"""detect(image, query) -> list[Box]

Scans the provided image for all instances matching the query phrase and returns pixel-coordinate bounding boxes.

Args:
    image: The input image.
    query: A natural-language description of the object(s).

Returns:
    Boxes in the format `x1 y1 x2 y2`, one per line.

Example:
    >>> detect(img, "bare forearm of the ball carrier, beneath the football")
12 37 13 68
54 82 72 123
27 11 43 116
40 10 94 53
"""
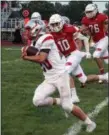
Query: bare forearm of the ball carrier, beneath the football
22 49 50 63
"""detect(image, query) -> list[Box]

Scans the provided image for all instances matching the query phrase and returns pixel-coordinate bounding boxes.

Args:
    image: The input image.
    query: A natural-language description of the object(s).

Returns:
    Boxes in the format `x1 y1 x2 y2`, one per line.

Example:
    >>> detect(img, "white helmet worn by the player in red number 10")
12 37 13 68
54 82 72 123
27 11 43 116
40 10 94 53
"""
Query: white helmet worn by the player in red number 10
49 14 64 32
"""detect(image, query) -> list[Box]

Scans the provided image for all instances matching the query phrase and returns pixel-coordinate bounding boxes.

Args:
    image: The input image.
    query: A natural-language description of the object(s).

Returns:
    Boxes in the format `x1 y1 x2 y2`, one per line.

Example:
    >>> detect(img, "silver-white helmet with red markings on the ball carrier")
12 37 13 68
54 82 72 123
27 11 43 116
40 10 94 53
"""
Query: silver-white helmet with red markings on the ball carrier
25 20 45 40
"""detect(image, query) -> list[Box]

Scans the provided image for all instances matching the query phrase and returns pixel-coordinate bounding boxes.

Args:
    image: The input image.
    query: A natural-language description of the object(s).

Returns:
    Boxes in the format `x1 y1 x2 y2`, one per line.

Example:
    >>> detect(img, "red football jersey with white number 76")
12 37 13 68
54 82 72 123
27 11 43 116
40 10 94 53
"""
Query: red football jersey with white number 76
81 13 108 43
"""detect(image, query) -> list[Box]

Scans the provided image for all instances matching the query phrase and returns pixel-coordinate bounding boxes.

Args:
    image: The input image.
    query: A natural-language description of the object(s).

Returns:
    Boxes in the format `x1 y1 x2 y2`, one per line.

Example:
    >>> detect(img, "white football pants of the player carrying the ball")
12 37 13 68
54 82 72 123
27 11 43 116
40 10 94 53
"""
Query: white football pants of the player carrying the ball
33 73 73 112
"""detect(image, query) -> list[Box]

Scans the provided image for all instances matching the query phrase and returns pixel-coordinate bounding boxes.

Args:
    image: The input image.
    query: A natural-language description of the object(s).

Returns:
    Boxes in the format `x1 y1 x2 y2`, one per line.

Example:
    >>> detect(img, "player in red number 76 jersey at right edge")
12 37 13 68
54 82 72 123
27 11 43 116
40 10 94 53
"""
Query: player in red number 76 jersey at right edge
81 4 109 82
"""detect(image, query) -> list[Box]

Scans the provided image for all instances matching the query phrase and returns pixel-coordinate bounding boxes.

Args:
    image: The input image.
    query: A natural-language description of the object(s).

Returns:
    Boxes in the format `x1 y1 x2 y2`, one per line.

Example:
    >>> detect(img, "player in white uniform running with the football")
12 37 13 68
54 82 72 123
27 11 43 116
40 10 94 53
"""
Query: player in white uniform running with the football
22 21 96 132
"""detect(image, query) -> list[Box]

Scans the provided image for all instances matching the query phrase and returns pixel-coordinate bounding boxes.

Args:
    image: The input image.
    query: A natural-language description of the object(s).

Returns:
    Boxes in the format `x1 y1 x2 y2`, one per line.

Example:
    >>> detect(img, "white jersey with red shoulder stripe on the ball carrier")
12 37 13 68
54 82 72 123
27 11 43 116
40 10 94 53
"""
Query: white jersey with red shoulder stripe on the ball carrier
31 34 66 82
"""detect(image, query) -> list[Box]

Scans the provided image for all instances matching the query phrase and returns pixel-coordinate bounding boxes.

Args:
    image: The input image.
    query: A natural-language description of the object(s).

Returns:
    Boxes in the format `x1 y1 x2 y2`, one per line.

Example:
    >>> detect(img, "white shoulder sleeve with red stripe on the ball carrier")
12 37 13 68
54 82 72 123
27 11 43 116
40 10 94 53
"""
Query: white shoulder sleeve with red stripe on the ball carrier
40 35 54 50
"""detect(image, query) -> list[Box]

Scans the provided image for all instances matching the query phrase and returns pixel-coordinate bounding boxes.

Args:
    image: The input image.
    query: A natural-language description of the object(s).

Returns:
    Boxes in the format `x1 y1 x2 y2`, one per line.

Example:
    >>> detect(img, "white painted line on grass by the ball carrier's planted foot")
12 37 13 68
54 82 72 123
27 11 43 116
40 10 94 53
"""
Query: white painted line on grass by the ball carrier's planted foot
63 97 108 135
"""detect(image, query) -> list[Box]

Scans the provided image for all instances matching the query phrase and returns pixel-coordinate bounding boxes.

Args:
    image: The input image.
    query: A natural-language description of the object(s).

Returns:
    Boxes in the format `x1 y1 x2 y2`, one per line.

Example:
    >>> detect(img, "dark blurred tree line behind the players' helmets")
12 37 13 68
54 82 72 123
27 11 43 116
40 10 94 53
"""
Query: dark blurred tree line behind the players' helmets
23 0 92 23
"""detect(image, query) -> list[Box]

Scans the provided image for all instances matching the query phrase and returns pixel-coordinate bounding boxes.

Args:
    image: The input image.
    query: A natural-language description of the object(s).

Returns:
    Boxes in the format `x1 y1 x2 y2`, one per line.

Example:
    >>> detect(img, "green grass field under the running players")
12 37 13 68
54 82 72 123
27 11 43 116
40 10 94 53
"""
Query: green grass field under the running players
1 47 108 135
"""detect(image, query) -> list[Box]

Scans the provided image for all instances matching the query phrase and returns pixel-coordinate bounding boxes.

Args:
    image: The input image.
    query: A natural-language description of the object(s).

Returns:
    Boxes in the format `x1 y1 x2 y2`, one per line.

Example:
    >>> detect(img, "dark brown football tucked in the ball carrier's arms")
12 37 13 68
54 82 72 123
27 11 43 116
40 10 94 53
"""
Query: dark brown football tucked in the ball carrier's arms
22 46 38 56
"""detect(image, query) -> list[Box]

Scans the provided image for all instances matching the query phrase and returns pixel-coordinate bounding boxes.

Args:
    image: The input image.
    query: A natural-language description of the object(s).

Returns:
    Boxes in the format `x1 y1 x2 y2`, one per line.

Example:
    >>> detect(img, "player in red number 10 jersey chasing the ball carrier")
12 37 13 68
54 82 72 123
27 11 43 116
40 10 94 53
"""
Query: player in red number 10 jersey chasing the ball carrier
49 14 108 92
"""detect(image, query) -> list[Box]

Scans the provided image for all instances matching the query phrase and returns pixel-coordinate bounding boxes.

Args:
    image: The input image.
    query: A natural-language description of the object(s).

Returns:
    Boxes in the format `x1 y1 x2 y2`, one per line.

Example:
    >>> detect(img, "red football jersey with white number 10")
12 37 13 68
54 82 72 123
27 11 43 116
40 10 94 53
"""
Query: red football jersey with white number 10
51 24 77 56
